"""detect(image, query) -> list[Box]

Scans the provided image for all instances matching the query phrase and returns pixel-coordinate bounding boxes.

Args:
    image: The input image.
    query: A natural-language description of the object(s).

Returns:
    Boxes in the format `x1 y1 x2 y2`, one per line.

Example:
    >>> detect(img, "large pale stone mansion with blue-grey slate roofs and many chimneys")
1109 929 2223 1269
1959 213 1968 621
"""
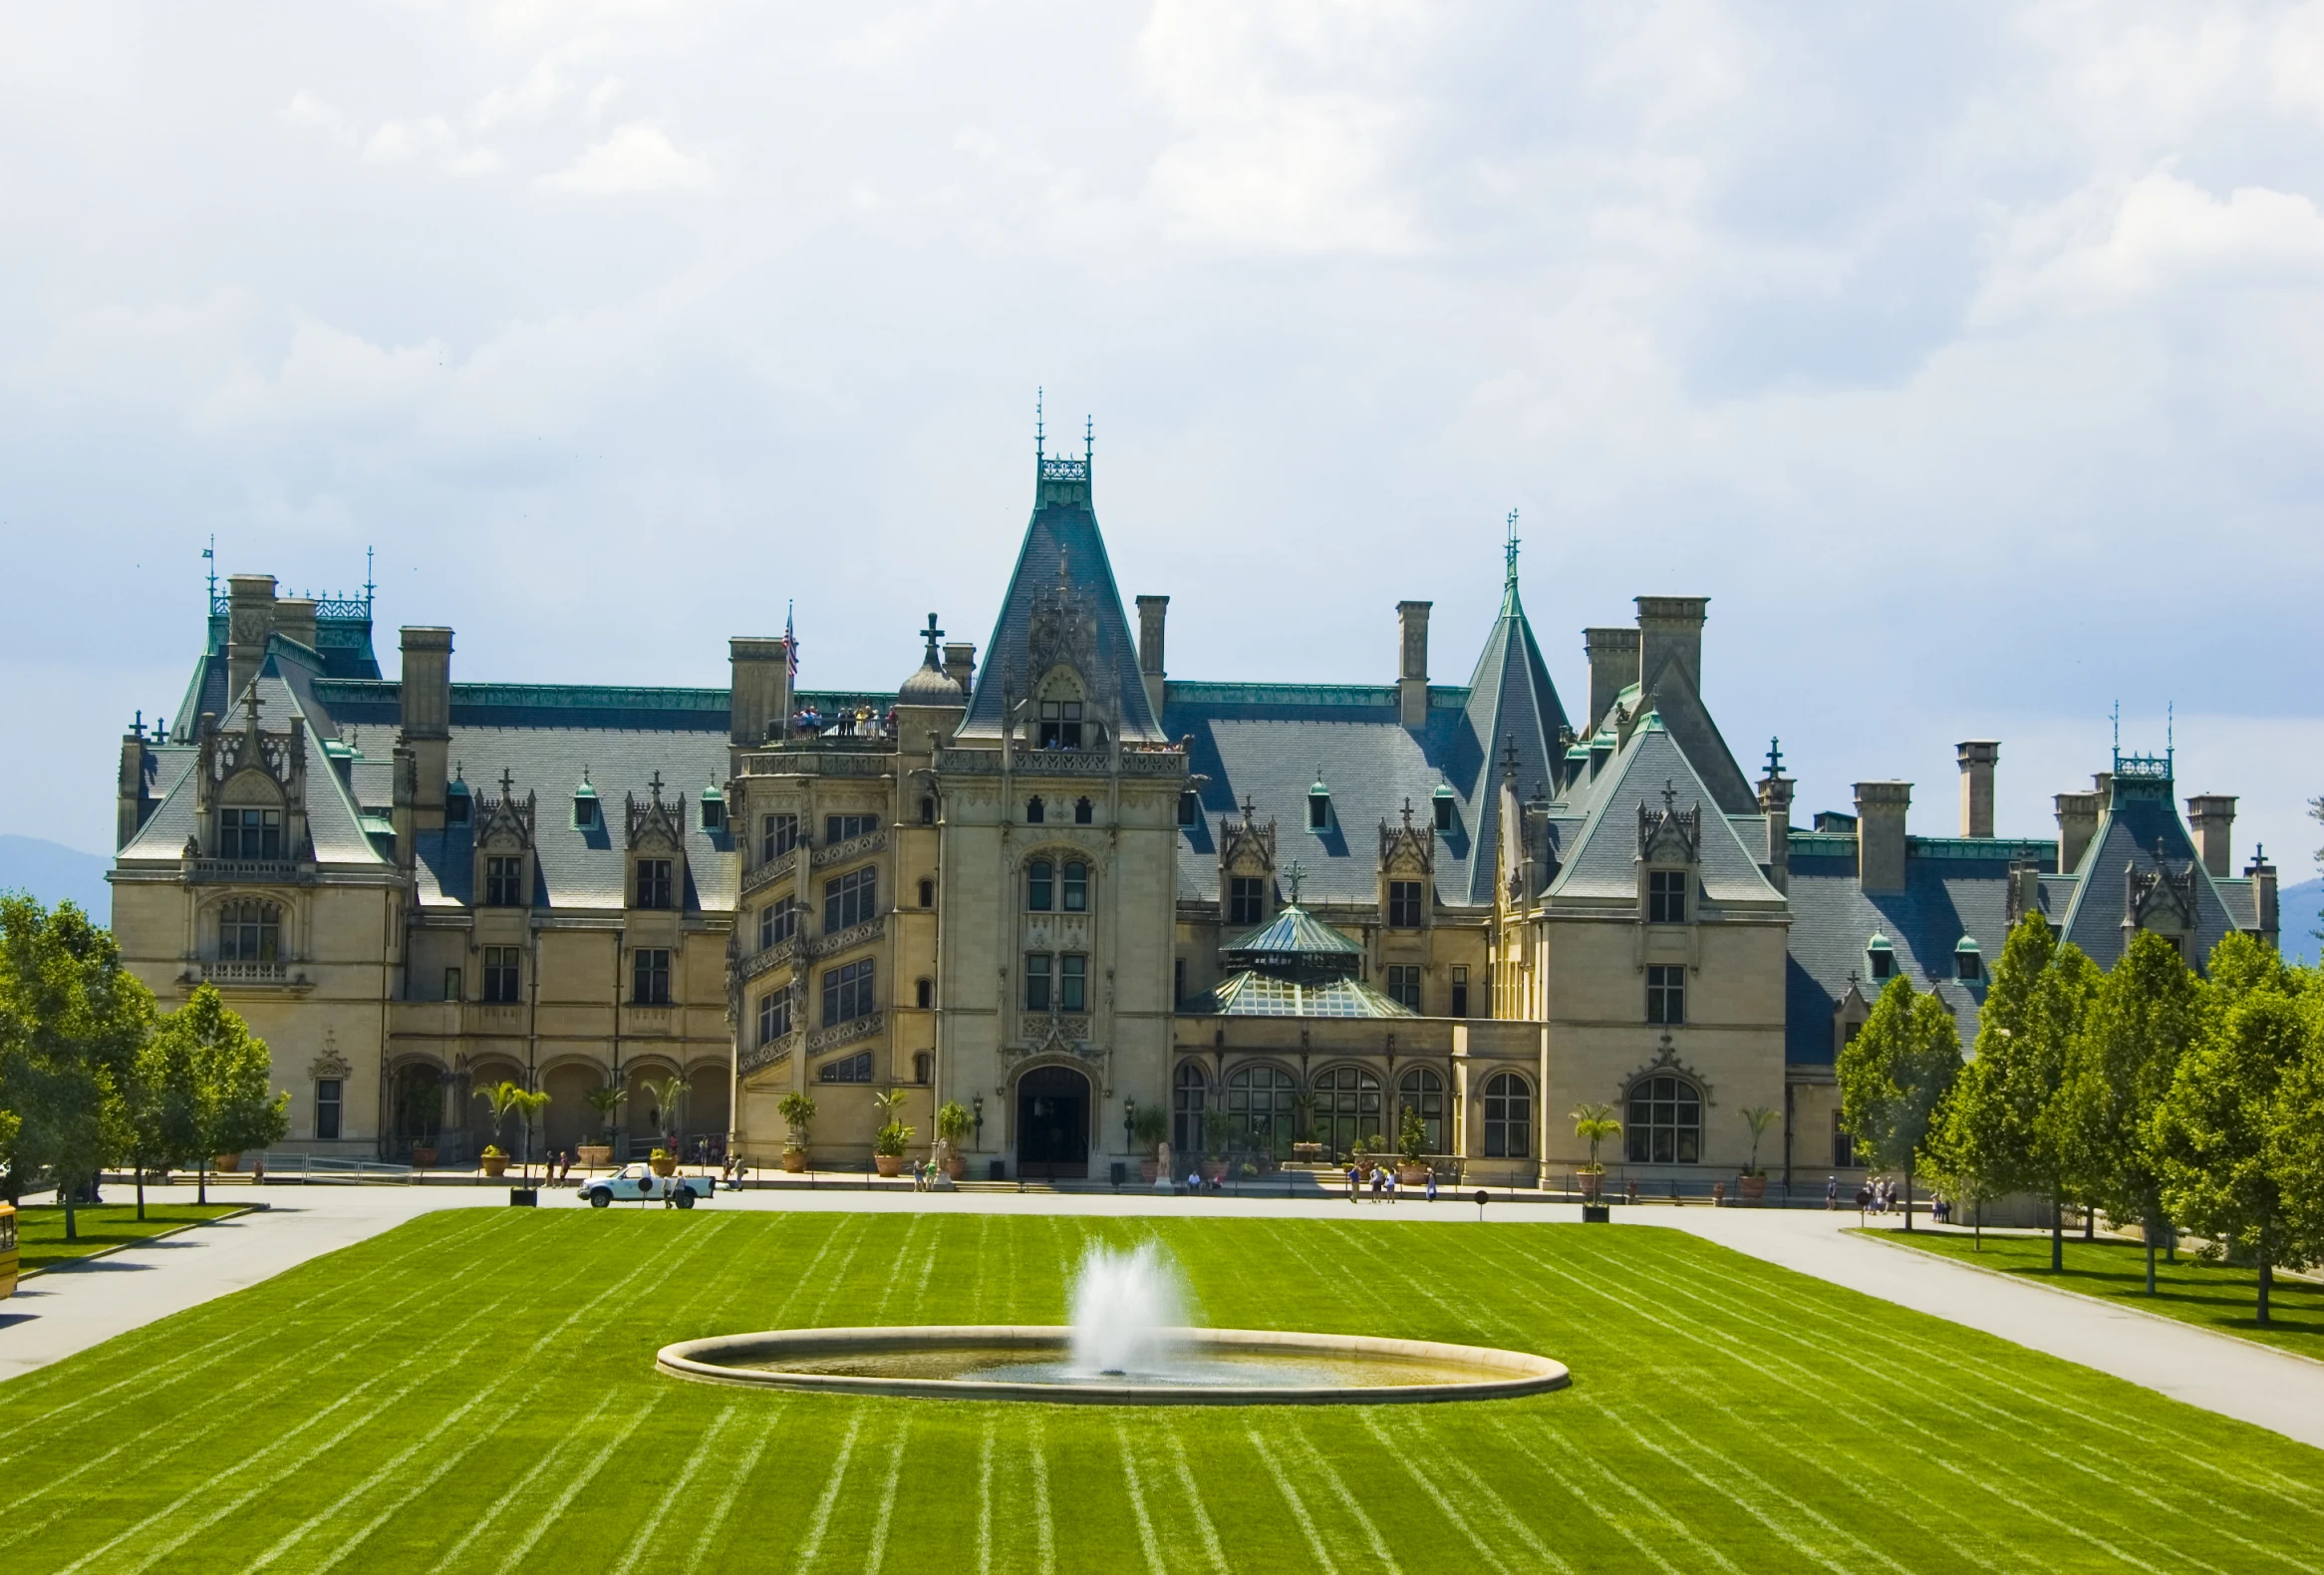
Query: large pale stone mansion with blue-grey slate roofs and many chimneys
112 432 2275 1187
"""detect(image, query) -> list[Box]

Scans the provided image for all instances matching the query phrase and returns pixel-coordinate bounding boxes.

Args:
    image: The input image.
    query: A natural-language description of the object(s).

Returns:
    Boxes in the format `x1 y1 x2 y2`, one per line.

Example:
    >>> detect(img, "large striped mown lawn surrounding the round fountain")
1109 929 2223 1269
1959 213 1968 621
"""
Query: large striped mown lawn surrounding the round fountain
0 1208 2324 1575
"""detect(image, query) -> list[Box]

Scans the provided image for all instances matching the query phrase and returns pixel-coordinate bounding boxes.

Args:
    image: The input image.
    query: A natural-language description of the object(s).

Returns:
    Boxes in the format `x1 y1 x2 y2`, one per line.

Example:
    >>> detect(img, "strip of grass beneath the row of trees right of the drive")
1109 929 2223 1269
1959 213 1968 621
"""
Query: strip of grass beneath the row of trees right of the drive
1874 1231 2324 1359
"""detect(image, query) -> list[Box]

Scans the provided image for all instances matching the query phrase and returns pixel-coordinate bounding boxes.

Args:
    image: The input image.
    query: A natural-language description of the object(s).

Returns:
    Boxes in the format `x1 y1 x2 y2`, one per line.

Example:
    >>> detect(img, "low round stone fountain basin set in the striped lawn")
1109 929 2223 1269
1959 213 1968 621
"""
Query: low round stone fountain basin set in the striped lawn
656 1324 1569 1406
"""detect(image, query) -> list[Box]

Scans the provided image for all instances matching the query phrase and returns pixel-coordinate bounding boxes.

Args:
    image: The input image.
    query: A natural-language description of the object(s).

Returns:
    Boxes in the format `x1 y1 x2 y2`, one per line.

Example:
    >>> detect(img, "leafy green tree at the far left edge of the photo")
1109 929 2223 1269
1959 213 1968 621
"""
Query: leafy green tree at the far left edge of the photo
0 894 153 1240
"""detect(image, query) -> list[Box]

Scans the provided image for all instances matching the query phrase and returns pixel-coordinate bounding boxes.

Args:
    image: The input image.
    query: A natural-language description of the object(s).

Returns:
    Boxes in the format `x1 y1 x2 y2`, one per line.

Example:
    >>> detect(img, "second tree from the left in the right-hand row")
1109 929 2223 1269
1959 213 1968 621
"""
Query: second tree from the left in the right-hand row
1933 913 2099 1273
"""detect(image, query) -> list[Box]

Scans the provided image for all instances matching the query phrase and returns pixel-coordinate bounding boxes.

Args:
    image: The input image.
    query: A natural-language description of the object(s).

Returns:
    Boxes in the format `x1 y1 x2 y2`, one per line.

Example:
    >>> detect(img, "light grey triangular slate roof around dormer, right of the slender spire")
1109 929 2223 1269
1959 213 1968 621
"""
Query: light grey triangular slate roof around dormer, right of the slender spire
1543 711 1783 911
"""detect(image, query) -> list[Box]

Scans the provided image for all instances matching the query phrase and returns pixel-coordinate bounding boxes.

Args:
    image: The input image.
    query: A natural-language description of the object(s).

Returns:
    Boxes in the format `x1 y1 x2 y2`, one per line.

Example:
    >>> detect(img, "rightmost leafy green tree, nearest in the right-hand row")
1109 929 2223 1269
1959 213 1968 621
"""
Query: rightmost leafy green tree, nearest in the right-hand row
2152 931 2319 1324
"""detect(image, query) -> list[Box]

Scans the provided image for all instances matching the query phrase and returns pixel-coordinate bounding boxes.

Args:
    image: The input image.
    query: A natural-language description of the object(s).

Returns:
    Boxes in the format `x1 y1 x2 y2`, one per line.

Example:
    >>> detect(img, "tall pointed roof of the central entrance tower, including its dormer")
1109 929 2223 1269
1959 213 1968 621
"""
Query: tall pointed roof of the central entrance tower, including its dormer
960 416 1164 748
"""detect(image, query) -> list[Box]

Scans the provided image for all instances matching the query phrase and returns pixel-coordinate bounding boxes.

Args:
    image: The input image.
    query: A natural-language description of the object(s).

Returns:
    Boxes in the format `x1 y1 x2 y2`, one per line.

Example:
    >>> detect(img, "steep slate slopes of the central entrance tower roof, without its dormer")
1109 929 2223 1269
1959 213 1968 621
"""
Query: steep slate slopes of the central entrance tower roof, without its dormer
960 456 1164 744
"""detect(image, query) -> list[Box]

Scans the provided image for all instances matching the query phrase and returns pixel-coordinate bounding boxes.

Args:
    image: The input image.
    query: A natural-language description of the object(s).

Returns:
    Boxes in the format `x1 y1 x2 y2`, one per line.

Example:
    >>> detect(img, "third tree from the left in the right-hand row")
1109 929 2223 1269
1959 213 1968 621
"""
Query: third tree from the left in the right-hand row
2059 929 2203 1296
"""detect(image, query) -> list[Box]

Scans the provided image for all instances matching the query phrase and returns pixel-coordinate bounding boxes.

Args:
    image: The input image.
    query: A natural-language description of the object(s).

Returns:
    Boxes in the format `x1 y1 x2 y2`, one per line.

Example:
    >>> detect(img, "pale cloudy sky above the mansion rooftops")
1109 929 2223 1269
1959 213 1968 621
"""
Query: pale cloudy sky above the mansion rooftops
0 0 2324 880
